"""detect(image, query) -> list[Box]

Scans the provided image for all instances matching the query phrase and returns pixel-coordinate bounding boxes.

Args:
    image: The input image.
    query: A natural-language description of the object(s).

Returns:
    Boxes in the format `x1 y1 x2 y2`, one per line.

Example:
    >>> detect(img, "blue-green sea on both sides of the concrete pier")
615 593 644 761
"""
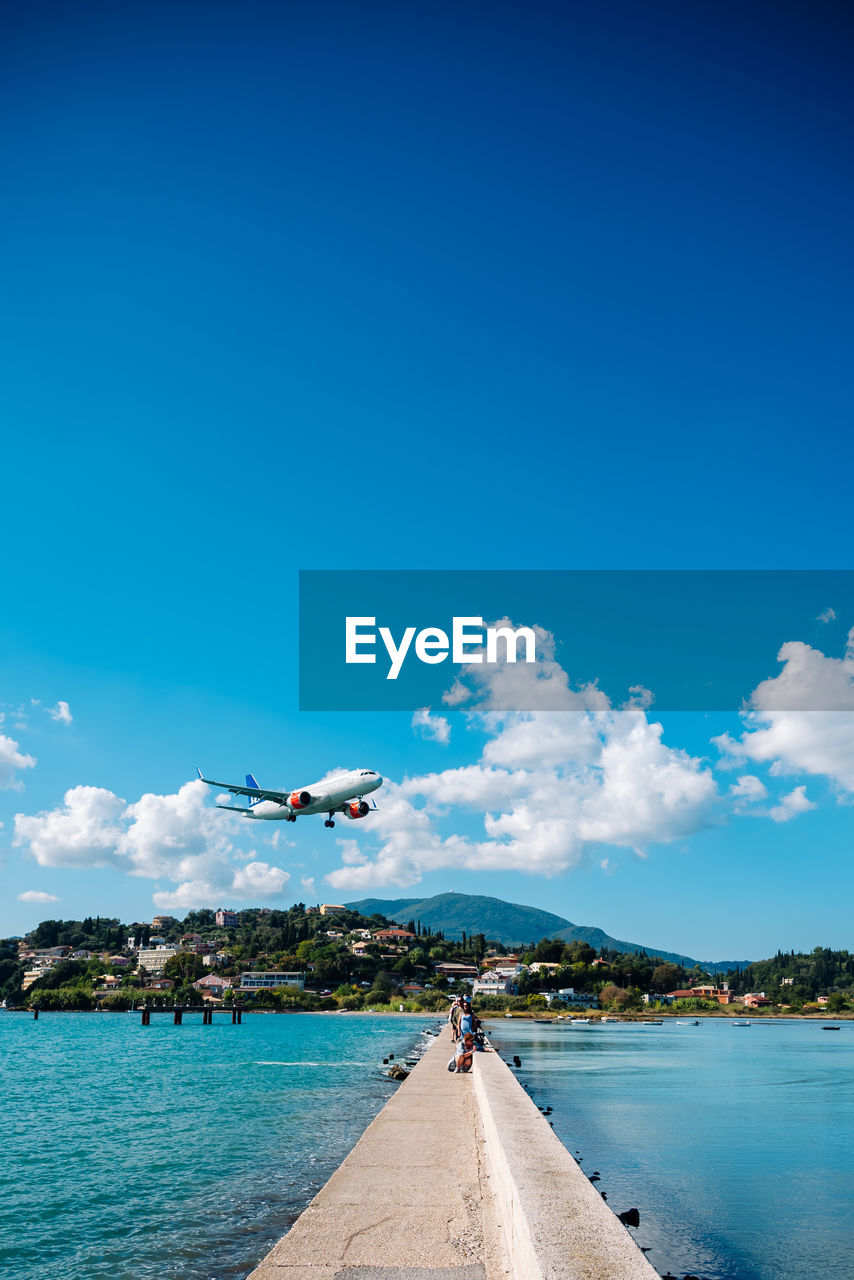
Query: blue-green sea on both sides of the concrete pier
0 1011 854 1280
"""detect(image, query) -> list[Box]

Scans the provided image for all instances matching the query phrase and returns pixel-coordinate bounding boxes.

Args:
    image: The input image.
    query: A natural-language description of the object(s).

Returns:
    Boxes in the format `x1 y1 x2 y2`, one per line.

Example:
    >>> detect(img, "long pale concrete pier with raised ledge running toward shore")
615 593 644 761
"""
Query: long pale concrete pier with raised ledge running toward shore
248 1029 658 1280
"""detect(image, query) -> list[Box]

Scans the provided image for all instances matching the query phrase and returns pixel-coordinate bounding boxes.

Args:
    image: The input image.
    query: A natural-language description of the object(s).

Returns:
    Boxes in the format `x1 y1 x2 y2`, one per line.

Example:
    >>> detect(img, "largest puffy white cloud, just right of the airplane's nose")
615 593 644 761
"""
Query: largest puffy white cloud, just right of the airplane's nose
326 620 717 890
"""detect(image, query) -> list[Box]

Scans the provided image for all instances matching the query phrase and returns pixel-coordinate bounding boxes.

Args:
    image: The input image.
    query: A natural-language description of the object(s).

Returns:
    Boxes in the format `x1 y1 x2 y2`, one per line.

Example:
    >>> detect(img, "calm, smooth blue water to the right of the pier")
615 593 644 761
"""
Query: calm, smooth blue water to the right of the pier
489 1019 854 1280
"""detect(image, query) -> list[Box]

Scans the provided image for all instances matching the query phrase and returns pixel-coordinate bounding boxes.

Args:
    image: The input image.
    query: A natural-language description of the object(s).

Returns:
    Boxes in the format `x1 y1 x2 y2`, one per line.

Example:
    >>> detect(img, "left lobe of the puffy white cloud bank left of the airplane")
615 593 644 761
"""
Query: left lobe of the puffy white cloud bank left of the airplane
13 787 125 868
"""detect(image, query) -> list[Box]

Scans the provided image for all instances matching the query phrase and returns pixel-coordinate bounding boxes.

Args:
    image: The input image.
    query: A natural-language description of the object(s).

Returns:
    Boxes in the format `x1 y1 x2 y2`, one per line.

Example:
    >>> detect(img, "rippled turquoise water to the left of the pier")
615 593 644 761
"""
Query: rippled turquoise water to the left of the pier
0 1012 437 1280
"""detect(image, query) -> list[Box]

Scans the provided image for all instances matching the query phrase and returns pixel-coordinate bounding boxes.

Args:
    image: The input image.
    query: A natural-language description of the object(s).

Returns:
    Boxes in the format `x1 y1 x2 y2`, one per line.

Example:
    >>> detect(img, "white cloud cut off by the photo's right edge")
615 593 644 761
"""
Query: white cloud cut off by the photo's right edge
713 630 854 792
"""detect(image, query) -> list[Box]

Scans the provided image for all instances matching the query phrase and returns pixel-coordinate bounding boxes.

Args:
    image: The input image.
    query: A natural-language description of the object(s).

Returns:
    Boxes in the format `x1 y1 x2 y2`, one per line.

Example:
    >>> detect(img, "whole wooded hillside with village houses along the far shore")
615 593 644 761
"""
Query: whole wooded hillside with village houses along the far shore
0 902 854 1014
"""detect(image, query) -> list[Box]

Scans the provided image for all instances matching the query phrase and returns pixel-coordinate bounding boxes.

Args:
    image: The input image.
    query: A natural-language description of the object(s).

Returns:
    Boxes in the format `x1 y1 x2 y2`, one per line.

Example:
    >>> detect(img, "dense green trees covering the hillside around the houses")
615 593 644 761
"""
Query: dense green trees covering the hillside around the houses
0 902 854 1012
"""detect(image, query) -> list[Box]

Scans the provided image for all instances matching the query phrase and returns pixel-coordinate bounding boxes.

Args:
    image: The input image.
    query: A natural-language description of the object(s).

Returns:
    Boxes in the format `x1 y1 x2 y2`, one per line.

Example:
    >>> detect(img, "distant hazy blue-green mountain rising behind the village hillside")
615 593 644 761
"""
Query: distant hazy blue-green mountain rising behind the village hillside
347 893 749 973
